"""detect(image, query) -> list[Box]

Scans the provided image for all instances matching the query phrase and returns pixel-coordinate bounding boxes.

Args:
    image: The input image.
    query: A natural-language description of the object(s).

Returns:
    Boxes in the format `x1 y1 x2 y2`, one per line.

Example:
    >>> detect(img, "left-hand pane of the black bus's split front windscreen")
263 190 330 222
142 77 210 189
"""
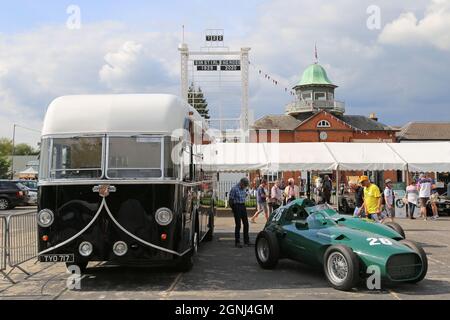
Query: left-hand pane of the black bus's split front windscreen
48 137 103 179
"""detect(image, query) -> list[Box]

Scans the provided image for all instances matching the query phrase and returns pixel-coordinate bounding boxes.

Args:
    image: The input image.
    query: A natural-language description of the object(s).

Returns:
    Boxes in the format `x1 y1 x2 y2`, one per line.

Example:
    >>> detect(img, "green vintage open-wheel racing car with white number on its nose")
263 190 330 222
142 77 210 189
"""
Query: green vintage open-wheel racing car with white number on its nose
255 199 428 290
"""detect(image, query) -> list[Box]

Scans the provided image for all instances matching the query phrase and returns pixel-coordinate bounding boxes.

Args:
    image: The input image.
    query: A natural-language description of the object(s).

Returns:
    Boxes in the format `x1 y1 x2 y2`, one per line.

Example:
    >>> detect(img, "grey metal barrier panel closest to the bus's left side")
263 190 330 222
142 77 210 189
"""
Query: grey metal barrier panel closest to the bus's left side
8 212 38 271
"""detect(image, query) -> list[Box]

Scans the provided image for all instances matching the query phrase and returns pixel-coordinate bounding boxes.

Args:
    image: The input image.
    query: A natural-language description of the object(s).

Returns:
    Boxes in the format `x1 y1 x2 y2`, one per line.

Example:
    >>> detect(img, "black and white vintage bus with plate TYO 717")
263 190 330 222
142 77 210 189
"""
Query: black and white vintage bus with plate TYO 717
37 94 216 271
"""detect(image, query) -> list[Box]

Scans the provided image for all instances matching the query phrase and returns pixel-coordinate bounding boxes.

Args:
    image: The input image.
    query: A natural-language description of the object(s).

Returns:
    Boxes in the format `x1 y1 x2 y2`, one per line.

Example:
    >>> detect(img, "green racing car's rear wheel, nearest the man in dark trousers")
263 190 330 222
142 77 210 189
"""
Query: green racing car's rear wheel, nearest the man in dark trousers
255 231 280 269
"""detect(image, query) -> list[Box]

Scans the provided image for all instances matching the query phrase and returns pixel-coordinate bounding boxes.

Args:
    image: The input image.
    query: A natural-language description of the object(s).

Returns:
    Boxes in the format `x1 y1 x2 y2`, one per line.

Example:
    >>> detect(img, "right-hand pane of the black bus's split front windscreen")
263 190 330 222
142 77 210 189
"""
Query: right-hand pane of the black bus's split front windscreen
107 136 162 179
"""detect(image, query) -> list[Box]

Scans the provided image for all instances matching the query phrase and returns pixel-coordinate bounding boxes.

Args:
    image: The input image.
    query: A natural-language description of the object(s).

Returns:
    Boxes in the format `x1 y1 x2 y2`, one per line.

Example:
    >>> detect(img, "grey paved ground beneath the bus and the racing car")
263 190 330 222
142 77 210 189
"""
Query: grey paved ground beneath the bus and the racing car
0 217 450 300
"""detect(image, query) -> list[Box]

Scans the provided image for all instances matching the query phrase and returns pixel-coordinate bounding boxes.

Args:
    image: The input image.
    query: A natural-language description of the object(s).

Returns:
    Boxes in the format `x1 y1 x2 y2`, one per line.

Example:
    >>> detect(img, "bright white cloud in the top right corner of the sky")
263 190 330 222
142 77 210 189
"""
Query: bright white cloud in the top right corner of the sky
379 0 450 51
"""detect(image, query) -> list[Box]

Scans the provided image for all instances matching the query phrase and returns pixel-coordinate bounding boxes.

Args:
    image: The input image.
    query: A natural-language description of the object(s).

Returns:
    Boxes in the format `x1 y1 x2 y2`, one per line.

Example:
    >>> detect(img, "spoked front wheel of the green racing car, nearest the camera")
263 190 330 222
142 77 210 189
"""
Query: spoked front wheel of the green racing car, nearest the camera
324 245 360 291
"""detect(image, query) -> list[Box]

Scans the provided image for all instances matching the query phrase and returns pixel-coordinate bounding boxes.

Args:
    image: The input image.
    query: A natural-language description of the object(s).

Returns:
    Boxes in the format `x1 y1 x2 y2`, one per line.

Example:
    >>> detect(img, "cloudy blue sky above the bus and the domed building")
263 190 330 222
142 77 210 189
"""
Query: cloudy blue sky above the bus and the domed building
0 0 450 145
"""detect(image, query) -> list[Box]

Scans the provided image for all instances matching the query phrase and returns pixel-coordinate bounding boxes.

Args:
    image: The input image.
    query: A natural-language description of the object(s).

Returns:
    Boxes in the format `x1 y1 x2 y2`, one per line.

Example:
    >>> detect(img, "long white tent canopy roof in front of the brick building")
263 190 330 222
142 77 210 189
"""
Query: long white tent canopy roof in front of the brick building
203 142 450 172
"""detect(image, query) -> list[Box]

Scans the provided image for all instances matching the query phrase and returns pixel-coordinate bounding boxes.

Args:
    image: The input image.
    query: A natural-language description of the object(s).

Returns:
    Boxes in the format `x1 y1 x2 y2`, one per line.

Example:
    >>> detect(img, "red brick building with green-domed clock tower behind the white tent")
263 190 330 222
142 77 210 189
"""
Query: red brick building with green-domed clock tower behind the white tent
250 63 401 188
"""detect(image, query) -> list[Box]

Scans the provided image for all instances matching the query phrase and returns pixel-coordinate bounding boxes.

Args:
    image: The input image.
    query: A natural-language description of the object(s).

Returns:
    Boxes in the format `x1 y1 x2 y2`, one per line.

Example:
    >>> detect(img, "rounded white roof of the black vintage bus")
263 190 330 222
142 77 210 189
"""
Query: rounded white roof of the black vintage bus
42 94 207 136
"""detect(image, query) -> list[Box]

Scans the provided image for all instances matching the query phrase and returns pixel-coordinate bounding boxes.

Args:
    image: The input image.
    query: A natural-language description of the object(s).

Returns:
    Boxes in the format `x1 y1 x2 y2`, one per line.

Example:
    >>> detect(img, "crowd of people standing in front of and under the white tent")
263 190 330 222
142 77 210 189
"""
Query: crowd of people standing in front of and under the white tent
229 173 439 248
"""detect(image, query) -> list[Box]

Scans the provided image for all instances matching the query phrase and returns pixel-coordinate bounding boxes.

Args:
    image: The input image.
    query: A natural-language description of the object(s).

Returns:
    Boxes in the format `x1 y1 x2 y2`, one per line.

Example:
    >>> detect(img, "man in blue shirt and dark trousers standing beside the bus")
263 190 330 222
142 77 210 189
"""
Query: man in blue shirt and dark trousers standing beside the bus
229 178 250 248
